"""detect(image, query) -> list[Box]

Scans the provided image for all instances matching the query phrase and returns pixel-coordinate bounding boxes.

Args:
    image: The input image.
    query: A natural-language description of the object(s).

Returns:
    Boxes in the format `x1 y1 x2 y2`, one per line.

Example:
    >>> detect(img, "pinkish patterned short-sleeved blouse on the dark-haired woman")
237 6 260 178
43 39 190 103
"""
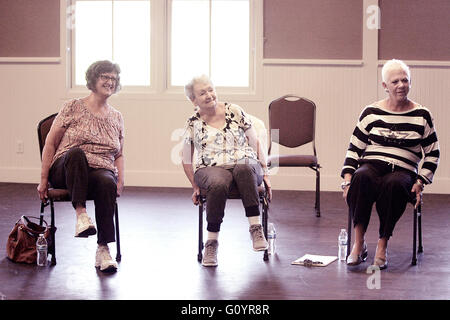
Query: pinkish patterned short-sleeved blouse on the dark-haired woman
52 99 124 174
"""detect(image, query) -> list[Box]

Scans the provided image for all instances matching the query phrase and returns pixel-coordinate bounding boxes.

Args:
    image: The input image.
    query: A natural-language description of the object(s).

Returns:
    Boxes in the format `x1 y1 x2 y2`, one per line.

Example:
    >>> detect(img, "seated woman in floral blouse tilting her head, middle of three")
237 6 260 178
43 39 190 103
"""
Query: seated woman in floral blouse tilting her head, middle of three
183 76 271 266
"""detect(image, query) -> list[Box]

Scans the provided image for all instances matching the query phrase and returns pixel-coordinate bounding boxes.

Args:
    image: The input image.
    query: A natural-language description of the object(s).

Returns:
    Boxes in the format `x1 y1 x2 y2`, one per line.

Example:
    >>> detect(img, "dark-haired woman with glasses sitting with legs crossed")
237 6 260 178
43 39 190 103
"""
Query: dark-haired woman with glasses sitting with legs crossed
37 61 124 271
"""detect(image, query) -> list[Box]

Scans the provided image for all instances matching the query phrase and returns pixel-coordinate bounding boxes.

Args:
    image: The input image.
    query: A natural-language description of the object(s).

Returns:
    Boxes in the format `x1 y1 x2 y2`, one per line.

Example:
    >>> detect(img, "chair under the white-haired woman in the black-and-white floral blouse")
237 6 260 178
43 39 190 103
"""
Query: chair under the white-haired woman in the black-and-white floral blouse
197 115 269 262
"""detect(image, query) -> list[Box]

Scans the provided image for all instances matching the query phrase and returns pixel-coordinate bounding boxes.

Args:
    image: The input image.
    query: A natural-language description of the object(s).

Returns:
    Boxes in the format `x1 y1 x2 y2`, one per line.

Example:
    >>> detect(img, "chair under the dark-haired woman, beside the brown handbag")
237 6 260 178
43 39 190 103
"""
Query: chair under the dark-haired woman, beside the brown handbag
37 113 122 266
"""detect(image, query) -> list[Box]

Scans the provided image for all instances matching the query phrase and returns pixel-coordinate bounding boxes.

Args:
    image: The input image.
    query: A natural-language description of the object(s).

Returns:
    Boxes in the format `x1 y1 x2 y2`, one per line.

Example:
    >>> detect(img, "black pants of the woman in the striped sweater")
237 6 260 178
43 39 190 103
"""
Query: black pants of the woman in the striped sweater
347 161 416 239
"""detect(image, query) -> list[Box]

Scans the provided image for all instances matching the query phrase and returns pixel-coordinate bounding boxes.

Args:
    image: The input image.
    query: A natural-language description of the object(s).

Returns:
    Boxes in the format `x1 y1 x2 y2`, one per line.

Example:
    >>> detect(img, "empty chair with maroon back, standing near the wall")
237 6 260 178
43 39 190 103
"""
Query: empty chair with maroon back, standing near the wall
268 95 321 217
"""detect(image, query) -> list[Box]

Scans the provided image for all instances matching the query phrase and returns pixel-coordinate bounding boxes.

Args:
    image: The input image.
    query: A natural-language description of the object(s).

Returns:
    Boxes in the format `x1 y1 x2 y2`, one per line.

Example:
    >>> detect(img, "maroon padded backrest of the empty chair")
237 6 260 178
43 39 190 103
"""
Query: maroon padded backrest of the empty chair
269 95 316 154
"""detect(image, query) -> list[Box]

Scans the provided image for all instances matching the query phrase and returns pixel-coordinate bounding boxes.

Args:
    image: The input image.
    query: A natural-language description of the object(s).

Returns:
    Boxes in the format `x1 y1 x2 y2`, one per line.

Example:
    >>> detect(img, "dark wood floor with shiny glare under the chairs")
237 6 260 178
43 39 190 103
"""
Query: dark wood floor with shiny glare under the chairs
0 183 450 300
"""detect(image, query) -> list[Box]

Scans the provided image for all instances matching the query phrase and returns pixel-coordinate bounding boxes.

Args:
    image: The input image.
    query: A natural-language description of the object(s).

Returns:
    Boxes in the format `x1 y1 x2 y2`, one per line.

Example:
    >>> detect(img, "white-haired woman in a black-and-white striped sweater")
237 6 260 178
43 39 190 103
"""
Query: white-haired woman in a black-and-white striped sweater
341 59 439 269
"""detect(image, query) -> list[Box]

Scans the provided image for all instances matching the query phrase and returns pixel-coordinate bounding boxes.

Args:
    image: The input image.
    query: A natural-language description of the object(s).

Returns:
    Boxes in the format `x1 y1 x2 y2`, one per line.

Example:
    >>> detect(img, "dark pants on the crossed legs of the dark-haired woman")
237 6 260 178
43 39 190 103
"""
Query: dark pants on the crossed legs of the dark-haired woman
49 148 117 244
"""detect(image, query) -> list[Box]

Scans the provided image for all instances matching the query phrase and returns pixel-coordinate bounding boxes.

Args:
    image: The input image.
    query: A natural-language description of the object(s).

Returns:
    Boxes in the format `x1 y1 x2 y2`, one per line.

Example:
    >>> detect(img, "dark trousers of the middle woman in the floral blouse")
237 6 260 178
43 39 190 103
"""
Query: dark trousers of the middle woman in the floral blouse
194 162 263 232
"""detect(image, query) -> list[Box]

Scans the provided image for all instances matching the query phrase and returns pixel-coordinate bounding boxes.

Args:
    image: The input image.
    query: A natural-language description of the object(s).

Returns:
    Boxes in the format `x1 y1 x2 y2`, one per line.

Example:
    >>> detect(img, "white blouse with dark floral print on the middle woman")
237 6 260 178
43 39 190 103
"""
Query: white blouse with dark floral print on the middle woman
184 103 257 171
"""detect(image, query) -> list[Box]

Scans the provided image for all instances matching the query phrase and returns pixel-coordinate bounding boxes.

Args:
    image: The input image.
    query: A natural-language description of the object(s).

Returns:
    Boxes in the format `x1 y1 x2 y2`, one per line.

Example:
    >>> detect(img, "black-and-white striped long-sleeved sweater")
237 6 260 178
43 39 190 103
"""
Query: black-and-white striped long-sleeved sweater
341 105 439 184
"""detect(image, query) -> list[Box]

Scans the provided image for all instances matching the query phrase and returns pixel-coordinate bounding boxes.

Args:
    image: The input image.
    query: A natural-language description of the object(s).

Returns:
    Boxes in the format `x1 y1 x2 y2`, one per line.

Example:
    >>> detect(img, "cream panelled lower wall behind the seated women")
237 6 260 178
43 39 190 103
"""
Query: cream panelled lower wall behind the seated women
0 0 450 193
